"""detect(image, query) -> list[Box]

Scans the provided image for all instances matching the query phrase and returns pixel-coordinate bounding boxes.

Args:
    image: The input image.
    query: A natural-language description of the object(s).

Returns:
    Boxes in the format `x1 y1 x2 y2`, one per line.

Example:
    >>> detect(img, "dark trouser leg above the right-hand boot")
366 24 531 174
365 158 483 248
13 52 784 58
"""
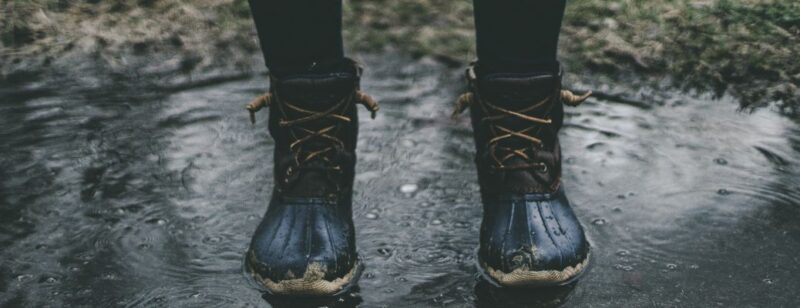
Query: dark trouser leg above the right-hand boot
473 0 566 74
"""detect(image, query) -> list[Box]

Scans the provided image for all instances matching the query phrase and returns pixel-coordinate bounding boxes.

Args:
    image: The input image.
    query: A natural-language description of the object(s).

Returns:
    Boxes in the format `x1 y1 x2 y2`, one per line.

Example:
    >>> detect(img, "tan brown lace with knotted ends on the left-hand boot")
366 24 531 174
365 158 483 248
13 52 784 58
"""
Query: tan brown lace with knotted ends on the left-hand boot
245 91 379 183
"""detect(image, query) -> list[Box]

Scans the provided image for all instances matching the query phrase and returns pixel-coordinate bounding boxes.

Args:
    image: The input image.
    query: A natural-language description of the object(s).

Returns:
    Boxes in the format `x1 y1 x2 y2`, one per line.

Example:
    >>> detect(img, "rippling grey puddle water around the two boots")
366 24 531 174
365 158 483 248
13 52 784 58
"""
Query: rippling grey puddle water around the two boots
0 57 800 307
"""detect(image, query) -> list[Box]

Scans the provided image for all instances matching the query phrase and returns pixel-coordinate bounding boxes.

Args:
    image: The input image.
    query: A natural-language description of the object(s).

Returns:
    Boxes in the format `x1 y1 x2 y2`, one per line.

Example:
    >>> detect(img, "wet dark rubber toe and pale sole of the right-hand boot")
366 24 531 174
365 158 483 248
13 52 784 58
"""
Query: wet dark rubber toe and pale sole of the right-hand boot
478 189 589 286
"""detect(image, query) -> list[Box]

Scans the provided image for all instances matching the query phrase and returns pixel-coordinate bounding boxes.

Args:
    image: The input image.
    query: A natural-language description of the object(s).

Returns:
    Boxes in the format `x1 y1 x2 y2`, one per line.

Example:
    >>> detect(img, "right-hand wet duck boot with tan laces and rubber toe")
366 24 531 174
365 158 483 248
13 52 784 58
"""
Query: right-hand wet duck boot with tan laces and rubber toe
454 65 589 287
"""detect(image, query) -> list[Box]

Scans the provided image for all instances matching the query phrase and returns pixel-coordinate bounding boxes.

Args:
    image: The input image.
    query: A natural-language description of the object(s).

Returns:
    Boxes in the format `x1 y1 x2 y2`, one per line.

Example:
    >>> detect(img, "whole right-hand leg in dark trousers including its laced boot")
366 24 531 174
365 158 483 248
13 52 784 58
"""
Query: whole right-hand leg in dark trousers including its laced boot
459 0 589 286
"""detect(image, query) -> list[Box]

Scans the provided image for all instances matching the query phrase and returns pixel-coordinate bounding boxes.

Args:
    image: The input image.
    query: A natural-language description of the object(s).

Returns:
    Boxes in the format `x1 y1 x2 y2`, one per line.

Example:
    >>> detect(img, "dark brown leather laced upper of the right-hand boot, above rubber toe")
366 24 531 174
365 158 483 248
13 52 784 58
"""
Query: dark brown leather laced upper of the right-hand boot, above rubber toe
462 65 564 194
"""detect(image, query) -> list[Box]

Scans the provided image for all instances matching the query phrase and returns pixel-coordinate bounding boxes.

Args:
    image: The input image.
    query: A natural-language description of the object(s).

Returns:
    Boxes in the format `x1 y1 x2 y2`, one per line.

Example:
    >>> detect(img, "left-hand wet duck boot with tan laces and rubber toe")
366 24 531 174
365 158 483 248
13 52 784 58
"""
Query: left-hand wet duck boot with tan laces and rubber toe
246 59 378 296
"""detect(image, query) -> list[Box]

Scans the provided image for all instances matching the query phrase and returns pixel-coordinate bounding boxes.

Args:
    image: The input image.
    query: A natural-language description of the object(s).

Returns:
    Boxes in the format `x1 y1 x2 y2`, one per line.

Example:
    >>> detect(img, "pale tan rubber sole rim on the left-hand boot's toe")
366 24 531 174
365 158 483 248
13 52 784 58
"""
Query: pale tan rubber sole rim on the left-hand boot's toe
244 253 364 299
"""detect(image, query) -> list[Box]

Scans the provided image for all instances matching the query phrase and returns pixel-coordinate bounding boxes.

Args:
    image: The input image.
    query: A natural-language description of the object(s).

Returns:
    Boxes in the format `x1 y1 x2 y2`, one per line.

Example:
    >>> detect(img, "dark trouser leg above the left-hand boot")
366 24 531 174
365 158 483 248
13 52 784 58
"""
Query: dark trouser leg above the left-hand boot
249 0 344 76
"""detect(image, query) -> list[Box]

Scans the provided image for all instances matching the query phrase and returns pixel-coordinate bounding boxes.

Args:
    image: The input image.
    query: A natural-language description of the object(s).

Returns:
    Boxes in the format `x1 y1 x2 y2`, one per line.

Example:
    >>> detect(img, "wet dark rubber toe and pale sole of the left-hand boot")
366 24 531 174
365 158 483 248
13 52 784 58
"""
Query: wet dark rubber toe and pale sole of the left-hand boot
247 199 360 296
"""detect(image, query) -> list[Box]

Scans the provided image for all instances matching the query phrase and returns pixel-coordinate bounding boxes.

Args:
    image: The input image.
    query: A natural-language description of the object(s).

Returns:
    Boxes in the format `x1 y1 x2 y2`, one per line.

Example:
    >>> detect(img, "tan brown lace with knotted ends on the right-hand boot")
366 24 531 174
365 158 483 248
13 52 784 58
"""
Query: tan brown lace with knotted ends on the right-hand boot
452 90 592 172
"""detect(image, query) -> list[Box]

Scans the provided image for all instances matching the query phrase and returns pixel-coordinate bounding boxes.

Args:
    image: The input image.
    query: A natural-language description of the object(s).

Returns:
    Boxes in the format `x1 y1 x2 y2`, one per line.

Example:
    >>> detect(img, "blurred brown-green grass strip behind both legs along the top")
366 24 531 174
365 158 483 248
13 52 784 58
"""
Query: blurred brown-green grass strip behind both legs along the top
0 0 800 115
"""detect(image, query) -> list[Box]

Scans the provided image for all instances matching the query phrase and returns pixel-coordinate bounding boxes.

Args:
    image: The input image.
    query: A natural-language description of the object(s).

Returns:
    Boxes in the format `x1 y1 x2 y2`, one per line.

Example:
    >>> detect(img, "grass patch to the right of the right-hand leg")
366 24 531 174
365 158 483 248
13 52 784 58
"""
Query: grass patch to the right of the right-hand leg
564 0 800 115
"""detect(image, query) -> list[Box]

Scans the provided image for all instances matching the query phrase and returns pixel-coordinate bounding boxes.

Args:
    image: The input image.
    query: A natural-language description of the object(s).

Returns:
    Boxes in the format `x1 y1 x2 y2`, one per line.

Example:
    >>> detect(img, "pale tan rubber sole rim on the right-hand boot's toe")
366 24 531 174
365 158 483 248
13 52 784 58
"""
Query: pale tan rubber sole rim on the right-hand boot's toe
475 251 592 288
